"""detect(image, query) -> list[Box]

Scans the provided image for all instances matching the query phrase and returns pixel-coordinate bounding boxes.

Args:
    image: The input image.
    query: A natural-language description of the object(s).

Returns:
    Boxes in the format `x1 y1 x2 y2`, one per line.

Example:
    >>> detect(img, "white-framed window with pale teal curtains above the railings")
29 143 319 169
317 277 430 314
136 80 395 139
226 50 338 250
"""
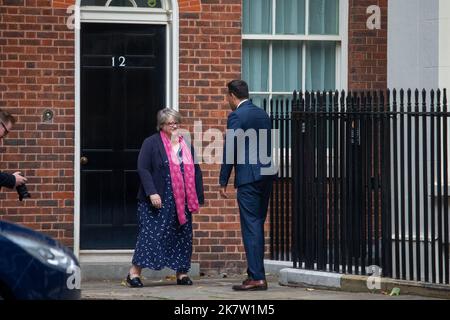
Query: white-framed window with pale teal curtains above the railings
242 0 345 105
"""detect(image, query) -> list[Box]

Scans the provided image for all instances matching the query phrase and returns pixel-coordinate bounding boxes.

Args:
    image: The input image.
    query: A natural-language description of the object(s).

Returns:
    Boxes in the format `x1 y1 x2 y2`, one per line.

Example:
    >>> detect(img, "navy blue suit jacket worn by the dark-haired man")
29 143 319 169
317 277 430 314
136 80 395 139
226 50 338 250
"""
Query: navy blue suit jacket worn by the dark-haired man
219 101 274 187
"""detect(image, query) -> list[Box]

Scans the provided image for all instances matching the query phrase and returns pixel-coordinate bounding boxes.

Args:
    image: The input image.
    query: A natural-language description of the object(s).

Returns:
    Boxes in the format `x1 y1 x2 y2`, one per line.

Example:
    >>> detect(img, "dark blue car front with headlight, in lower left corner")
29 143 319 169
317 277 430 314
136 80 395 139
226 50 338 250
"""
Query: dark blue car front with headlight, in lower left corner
0 221 81 300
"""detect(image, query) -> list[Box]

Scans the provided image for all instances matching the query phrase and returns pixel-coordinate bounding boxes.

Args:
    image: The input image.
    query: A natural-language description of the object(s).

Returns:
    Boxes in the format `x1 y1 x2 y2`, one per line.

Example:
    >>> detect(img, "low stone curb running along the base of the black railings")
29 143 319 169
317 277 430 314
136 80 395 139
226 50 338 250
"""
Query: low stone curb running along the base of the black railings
279 268 450 299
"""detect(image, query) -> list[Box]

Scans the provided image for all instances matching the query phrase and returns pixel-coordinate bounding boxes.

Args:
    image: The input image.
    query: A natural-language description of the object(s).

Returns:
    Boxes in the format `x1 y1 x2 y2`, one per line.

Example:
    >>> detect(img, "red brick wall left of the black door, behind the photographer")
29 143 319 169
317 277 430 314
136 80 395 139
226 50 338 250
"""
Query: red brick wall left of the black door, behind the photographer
0 0 75 246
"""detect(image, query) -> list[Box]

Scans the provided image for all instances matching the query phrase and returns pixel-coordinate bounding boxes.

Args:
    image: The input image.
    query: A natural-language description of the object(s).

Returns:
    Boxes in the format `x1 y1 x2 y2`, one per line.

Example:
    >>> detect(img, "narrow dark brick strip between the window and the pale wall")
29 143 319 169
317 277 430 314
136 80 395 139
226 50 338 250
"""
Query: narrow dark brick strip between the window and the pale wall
348 0 388 90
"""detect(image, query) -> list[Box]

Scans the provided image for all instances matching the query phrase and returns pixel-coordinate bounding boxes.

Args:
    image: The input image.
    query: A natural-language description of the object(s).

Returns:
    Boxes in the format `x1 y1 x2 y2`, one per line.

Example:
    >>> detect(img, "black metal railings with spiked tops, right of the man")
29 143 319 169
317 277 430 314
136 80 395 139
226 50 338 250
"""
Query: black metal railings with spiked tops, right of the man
264 90 450 284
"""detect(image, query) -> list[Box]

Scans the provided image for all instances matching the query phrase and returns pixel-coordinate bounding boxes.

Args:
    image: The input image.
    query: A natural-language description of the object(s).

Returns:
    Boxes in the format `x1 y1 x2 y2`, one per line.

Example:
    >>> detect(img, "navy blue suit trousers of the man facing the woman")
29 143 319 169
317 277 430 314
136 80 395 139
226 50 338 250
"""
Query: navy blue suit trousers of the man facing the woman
237 179 273 280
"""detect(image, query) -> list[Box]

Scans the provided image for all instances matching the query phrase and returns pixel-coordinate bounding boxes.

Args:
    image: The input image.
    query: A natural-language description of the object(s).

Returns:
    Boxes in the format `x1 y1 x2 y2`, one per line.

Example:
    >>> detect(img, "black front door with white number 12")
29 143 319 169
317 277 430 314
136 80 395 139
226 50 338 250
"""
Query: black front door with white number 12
80 23 166 250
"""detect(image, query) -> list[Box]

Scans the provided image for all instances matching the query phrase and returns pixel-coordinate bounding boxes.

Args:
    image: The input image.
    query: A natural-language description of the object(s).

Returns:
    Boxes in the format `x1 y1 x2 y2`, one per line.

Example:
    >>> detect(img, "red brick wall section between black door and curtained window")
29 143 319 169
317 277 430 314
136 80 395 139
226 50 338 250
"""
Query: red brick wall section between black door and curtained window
180 0 250 273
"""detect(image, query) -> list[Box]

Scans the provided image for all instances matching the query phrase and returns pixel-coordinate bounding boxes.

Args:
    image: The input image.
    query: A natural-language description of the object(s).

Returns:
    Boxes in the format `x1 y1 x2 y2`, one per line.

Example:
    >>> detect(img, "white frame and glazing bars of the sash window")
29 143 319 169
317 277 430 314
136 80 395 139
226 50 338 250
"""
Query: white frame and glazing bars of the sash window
242 0 349 101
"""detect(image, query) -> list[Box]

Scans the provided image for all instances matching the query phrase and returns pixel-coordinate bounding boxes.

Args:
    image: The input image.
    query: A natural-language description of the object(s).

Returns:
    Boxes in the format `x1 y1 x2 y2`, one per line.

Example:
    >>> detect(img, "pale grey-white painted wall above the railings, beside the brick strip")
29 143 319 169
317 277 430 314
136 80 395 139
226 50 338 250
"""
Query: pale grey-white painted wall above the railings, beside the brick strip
388 0 440 90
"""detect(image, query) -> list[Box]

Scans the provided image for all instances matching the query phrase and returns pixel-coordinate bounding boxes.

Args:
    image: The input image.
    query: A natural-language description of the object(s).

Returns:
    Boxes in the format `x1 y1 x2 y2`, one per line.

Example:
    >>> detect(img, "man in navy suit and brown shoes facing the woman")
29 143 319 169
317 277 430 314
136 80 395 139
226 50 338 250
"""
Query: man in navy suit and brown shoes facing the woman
219 80 274 291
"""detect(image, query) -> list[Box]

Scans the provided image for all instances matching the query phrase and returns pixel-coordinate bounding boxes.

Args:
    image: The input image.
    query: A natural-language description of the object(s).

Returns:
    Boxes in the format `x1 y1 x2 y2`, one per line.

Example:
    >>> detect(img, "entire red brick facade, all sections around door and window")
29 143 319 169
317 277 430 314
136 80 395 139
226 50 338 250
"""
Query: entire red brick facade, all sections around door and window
0 0 387 273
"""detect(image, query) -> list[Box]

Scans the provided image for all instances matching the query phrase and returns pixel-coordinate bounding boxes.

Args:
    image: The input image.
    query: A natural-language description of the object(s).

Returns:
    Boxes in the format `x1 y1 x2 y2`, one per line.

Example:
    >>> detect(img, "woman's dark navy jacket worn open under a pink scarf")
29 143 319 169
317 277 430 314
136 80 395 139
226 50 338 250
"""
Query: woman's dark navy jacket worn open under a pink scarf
137 132 205 204
